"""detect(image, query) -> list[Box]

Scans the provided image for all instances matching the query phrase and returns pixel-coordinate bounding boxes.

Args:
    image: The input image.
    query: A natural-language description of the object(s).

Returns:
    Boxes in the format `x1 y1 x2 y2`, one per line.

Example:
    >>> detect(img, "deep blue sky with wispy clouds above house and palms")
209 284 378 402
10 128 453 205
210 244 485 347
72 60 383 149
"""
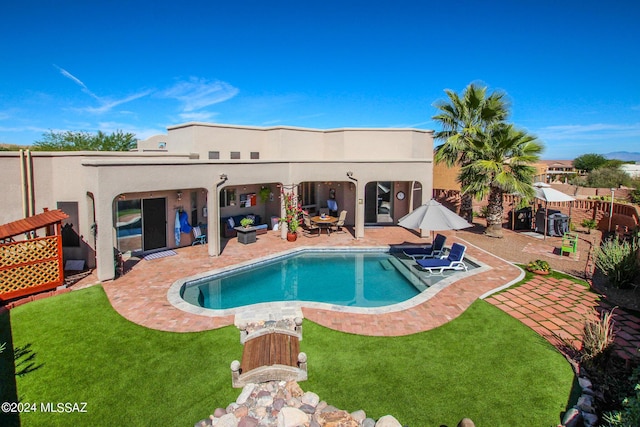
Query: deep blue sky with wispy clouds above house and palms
0 0 640 159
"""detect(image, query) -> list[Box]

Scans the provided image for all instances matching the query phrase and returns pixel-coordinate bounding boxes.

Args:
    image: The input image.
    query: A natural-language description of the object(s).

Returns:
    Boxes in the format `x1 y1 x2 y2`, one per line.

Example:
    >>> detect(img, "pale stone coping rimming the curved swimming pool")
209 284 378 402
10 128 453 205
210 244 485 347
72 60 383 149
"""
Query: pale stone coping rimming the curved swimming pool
167 245 492 324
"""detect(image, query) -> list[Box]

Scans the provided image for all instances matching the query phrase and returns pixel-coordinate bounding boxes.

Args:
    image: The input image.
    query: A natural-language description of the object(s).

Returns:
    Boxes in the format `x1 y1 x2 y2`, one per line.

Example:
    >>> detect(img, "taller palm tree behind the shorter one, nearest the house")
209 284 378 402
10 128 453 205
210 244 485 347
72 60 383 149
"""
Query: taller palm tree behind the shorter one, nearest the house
432 83 509 222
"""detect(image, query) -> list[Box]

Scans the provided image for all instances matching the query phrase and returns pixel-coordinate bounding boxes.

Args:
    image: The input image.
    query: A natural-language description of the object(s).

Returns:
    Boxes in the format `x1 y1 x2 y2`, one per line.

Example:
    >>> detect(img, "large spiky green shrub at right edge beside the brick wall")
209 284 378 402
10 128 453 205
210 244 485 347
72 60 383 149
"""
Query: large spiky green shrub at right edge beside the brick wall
595 236 640 289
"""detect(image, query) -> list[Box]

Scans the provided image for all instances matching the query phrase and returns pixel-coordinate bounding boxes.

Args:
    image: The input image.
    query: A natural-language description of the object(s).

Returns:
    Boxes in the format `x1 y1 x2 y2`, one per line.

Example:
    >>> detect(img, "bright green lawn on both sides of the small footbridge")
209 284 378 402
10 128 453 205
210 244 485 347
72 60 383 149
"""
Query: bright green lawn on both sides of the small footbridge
0 286 573 427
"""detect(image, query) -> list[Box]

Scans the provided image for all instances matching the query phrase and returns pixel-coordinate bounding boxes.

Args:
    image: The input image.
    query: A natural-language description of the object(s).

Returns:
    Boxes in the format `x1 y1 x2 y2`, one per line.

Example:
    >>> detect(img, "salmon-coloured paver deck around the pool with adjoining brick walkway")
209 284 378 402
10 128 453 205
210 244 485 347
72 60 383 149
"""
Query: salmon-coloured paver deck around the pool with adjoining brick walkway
63 227 640 358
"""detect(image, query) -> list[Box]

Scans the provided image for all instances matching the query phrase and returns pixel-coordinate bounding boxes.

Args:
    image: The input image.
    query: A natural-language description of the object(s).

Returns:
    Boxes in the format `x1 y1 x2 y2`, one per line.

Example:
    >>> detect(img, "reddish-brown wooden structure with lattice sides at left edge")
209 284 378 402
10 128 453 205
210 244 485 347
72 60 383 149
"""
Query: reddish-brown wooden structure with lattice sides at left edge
0 209 69 301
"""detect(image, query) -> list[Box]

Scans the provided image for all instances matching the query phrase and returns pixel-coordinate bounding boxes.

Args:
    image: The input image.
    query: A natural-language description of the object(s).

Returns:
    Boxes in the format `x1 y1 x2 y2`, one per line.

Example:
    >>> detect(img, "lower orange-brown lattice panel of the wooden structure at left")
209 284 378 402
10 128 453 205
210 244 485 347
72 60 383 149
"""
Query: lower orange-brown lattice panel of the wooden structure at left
0 260 62 294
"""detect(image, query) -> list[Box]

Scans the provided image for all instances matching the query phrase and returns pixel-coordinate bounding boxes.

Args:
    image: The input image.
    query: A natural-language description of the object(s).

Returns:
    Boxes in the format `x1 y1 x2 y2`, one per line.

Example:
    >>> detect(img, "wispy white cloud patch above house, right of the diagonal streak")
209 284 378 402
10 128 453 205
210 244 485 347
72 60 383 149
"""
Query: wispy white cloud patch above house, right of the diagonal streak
161 77 238 112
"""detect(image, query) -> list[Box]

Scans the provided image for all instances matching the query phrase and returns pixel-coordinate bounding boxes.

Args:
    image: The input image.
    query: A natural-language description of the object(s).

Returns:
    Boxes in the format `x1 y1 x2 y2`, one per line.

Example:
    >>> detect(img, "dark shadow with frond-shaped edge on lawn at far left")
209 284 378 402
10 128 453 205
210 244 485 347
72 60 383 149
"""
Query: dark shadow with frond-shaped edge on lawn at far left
0 307 43 427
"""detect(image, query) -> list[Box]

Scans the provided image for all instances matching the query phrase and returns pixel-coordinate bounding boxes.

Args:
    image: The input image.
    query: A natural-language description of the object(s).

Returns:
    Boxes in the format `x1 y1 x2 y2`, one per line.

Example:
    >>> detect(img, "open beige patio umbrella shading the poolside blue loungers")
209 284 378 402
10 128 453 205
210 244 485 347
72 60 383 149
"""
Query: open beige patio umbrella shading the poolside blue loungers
398 199 473 231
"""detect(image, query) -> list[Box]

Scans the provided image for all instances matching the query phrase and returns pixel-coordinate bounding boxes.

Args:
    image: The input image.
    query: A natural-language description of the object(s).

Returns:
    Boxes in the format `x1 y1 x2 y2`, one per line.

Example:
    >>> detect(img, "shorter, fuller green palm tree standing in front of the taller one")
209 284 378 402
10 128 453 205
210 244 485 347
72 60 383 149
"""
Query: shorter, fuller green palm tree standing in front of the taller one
460 123 543 237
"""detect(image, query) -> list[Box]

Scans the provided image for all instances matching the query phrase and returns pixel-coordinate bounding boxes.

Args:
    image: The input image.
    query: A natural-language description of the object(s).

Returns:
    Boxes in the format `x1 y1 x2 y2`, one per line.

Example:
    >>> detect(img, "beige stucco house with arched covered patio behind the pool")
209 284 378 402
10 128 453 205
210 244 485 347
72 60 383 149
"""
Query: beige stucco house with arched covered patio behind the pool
0 123 433 280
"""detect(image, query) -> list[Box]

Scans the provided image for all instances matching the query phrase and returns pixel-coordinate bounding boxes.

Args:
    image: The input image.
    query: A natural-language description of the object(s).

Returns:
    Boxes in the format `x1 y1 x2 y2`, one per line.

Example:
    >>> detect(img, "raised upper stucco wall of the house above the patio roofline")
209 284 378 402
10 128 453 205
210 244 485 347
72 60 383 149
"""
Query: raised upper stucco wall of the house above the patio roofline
138 123 433 164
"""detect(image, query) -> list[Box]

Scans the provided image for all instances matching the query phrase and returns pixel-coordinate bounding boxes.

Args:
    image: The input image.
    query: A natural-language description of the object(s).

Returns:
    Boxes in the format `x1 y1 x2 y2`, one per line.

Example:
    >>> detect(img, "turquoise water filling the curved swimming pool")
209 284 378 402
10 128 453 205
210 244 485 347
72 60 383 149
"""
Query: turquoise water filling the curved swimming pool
181 252 419 309
